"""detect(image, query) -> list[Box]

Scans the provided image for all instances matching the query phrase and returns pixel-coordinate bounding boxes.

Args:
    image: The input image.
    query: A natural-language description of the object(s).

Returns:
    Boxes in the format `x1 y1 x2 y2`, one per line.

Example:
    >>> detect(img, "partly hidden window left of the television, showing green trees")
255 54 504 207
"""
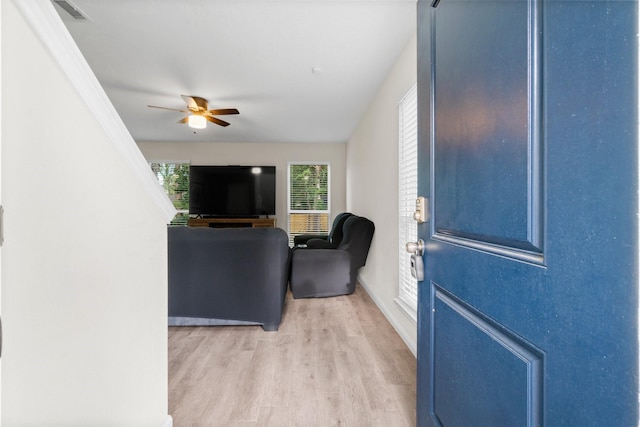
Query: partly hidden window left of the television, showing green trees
151 163 189 225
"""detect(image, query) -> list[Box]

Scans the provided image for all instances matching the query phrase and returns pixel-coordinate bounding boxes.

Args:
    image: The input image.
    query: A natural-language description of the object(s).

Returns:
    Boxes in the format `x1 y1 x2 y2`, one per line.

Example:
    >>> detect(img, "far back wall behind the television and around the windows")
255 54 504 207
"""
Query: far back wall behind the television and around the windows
138 142 346 230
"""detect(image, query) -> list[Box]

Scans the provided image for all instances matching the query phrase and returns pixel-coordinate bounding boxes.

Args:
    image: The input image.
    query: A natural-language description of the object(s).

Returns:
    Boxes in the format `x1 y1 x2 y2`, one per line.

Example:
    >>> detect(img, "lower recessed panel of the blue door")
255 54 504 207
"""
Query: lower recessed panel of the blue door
431 284 543 426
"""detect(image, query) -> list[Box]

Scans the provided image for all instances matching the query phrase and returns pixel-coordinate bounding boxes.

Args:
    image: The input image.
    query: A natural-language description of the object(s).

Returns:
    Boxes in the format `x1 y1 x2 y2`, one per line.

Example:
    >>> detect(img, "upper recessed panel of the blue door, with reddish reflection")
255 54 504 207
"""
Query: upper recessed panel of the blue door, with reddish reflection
432 1 537 247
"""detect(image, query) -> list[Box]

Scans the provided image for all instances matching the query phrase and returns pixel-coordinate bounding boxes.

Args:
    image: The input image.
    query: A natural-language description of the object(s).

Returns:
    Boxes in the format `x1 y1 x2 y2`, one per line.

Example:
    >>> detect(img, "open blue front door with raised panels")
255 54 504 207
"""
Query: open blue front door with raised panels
418 0 638 427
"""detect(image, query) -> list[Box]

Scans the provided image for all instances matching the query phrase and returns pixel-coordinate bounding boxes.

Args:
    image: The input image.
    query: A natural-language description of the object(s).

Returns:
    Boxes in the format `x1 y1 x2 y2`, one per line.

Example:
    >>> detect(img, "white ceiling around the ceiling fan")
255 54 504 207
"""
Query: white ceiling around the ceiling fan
55 0 416 143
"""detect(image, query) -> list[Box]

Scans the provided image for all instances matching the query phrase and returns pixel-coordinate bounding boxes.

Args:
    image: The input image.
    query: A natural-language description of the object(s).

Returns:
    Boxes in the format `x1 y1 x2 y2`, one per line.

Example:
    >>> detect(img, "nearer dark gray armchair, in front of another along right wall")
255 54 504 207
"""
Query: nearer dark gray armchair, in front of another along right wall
289 215 375 298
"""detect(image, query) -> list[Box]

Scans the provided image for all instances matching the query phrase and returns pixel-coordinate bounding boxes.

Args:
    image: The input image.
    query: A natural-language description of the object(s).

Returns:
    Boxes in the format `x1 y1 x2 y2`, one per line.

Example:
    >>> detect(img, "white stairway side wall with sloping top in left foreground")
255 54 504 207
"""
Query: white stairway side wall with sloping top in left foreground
1 1 168 427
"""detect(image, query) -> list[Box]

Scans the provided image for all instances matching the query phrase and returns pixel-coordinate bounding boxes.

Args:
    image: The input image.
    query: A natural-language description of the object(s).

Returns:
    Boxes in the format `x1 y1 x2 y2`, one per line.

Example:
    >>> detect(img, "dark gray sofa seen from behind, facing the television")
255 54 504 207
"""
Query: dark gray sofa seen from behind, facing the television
168 227 290 331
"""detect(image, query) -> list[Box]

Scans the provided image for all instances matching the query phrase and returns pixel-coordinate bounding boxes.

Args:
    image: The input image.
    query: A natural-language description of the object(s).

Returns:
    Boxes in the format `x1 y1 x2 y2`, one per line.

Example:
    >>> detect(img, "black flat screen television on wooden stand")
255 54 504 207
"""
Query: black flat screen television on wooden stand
189 166 276 218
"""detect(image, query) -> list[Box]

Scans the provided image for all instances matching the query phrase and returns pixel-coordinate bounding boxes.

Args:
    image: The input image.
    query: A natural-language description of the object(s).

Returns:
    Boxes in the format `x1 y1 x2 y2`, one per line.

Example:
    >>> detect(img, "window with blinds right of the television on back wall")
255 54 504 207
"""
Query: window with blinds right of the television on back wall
287 163 329 245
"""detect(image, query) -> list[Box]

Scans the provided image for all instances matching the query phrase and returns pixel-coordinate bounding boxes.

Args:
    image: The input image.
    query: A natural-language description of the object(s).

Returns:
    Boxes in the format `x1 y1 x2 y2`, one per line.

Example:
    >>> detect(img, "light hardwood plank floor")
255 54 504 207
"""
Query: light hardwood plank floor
169 285 416 427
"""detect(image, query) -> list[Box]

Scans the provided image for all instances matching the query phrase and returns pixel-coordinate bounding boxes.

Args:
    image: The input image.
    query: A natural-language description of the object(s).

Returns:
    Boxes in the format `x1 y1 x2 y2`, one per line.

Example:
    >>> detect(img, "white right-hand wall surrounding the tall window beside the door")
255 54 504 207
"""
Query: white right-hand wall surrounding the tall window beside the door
347 36 417 354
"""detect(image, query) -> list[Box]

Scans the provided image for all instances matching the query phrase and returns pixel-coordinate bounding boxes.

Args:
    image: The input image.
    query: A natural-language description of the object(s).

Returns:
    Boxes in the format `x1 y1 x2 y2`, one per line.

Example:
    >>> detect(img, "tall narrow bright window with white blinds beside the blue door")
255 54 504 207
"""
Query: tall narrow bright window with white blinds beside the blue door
398 85 418 316
